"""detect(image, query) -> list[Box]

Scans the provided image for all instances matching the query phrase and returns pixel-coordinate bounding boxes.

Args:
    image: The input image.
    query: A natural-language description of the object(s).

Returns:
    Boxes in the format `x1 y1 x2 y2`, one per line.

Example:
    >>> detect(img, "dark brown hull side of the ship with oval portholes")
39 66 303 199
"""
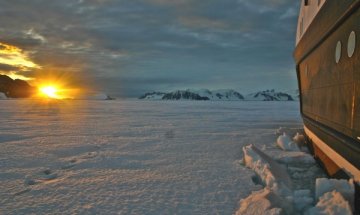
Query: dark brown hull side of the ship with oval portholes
294 0 360 180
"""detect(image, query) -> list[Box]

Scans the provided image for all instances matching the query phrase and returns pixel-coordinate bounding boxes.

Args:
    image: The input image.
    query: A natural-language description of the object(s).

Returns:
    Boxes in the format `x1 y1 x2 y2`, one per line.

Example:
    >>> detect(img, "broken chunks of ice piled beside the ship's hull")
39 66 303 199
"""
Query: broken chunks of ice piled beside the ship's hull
236 128 355 215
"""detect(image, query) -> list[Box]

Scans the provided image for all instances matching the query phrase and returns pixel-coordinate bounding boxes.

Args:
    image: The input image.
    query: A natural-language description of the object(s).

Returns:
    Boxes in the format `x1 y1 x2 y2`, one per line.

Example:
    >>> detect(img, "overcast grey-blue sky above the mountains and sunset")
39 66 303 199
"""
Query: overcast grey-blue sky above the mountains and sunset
0 0 299 96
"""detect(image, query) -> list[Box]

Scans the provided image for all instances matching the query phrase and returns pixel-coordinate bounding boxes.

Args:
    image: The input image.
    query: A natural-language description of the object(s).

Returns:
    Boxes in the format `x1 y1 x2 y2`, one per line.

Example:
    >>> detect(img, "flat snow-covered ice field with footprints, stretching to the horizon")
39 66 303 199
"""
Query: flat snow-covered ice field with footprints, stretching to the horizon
0 100 315 214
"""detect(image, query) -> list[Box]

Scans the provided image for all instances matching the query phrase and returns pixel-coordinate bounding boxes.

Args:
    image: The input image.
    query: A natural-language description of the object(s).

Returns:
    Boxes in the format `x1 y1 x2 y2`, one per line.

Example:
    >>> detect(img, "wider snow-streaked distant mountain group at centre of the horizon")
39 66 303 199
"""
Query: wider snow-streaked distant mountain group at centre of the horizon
139 89 244 101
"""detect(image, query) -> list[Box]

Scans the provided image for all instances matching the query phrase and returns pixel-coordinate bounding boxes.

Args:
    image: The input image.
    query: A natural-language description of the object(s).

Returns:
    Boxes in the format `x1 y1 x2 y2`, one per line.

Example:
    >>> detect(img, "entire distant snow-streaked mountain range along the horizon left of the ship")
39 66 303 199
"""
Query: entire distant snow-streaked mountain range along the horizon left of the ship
139 89 299 101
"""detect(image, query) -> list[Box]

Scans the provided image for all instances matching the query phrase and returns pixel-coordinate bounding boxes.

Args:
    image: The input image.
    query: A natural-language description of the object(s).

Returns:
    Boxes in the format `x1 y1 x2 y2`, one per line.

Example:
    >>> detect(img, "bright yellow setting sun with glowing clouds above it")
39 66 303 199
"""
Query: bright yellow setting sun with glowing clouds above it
0 41 87 99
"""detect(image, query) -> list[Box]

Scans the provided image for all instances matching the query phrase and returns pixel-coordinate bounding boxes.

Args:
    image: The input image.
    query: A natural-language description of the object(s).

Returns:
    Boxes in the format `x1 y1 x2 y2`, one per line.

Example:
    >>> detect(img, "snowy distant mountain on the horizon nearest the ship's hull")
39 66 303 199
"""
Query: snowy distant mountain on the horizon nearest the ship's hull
245 90 295 101
